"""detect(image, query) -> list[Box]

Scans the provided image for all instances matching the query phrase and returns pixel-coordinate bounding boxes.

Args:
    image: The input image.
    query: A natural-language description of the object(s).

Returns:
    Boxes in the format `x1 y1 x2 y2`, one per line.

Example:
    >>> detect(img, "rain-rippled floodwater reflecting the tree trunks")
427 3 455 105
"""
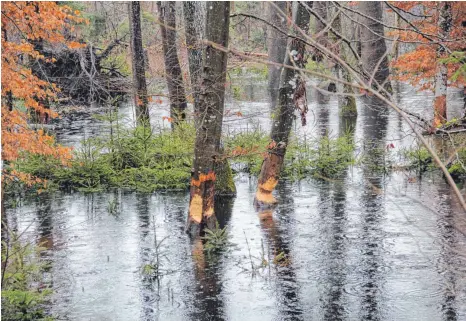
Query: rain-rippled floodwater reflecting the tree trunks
4 80 466 321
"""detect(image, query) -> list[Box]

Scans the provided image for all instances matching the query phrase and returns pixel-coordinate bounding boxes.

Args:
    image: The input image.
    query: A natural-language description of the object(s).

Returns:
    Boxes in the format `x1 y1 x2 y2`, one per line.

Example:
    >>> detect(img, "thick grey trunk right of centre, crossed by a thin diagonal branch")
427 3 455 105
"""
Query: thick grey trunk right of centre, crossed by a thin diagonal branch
359 1 392 92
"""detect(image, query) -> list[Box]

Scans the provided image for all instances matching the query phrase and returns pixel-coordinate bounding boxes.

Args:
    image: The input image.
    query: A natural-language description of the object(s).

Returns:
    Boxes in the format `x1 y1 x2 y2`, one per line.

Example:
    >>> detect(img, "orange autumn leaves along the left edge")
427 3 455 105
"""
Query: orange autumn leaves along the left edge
1 2 84 184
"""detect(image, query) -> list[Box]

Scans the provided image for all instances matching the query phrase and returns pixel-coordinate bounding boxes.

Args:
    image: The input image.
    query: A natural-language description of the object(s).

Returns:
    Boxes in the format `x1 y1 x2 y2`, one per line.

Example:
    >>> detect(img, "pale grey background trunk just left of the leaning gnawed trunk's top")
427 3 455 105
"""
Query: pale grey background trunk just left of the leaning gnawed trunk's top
267 1 288 111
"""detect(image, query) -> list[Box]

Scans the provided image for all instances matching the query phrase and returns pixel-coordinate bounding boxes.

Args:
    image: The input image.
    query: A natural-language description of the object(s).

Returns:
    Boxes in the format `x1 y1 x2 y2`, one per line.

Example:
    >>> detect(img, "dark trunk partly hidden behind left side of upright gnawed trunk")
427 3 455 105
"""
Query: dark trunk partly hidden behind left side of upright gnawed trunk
183 1 205 116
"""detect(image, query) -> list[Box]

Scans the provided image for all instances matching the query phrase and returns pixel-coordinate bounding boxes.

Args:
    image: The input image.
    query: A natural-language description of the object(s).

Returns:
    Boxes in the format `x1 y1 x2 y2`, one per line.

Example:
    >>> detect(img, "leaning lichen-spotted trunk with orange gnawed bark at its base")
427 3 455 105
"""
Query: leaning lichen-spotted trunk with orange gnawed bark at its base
255 4 310 206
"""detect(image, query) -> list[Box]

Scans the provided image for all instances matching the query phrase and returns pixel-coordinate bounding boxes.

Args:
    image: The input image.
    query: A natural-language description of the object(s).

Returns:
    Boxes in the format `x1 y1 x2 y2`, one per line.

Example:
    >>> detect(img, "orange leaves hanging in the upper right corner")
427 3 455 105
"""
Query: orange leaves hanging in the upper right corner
391 1 466 89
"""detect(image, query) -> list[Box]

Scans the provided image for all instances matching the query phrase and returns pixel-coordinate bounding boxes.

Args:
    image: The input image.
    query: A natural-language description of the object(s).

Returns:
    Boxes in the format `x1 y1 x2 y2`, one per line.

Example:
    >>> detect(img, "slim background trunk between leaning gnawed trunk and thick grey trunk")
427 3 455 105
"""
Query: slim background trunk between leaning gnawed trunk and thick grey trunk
333 13 358 118
